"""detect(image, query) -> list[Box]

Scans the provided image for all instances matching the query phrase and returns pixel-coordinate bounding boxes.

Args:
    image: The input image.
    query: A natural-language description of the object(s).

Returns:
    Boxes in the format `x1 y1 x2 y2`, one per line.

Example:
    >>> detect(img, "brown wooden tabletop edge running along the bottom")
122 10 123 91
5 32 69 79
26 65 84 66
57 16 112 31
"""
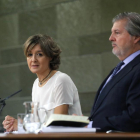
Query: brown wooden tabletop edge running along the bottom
0 132 140 140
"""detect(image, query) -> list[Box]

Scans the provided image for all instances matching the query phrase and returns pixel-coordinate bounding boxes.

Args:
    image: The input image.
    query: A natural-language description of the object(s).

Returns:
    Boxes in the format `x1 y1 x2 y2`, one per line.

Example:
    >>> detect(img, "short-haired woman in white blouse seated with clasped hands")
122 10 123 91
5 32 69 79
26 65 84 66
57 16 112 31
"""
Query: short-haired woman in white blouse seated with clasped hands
3 34 82 132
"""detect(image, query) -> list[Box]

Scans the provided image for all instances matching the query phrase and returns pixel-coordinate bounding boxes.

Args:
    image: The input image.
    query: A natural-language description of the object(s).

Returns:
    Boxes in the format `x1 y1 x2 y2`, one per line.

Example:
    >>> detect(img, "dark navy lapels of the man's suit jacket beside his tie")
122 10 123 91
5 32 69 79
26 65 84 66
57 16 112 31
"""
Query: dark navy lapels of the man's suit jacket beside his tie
93 55 140 113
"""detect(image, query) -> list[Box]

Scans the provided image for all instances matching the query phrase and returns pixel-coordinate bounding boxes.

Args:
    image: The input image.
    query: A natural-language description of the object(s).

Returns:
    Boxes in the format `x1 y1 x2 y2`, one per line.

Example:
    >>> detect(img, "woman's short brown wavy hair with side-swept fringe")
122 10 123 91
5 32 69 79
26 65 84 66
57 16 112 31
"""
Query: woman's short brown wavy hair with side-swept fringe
24 34 61 70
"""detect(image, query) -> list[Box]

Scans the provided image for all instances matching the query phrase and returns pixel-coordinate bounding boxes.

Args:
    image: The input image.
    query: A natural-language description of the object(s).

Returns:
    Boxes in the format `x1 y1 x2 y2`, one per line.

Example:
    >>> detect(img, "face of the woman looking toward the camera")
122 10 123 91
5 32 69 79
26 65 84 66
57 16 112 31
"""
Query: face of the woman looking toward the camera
27 44 51 75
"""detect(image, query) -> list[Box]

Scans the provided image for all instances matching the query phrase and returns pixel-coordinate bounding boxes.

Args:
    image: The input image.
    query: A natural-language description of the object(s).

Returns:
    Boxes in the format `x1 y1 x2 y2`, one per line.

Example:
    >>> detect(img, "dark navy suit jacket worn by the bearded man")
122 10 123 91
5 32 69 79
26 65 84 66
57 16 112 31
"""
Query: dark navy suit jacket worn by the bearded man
89 55 140 132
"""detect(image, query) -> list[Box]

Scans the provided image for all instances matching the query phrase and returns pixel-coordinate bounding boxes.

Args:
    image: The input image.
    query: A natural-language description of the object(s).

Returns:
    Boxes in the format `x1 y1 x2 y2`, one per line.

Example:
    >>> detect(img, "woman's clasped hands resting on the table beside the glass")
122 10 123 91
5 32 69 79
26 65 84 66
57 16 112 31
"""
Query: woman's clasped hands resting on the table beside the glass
2 116 17 132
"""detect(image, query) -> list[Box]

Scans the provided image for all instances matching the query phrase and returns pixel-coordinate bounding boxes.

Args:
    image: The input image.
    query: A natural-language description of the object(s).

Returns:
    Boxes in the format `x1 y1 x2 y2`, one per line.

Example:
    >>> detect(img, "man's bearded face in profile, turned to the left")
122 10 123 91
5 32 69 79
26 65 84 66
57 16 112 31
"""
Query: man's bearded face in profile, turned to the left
109 19 135 60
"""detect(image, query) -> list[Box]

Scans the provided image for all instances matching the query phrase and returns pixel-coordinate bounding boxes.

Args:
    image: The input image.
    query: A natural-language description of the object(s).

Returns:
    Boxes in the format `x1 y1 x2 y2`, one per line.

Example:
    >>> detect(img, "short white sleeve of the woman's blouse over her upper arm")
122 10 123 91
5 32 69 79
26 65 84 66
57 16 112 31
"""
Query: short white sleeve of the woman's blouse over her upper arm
54 74 76 107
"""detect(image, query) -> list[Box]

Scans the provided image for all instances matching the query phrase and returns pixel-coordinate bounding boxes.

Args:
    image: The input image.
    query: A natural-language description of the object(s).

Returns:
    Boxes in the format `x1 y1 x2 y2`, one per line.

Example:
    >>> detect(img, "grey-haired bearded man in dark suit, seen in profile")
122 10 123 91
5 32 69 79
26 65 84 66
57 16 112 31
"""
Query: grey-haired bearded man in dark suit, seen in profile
89 12 140 132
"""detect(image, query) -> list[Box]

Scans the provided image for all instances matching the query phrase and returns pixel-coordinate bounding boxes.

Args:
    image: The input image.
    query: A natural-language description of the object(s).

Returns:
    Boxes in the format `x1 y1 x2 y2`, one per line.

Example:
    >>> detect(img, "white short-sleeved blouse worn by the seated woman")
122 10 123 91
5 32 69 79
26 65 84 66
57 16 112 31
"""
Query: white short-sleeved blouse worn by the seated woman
32 71 82 122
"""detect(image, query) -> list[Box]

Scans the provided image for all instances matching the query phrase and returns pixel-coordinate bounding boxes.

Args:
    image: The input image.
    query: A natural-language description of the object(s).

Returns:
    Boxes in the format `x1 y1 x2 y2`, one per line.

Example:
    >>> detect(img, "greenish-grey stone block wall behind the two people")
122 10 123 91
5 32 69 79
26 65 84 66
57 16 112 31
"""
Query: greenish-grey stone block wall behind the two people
0 0 140 122
